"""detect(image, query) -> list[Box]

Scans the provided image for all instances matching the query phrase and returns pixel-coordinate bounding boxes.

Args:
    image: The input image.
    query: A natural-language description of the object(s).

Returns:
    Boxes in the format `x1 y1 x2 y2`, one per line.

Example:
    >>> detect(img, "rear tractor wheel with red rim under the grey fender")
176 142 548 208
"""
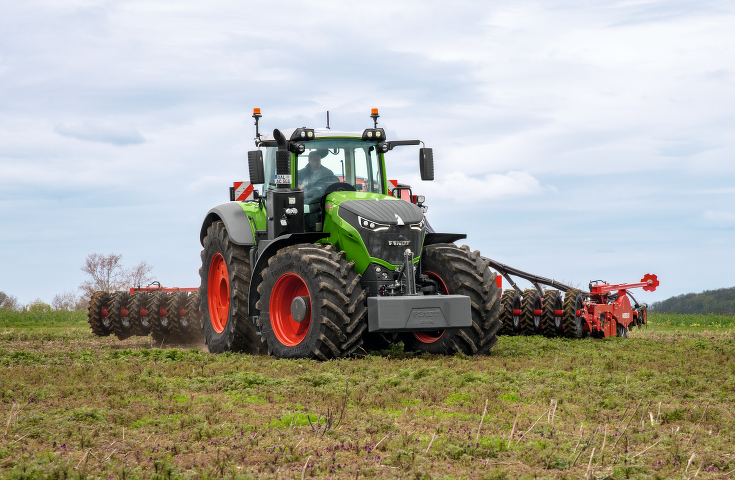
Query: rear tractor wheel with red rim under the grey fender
199 221 267 355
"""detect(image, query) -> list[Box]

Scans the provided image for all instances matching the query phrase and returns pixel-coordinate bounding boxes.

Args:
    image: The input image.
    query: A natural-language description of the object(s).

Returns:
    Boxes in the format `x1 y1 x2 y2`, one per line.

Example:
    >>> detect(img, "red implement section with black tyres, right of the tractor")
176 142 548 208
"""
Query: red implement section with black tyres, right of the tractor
486 255 659 338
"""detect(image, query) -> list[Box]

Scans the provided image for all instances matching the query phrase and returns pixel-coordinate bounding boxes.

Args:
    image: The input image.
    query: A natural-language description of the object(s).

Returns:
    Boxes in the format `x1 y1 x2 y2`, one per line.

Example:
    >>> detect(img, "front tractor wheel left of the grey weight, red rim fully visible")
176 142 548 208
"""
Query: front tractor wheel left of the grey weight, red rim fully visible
257 243 367 360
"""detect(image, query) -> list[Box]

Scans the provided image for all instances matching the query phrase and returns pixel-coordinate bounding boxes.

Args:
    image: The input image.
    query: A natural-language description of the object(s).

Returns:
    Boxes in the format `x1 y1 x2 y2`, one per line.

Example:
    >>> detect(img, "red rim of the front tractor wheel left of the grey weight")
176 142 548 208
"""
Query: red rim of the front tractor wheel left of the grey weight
270 273 311 347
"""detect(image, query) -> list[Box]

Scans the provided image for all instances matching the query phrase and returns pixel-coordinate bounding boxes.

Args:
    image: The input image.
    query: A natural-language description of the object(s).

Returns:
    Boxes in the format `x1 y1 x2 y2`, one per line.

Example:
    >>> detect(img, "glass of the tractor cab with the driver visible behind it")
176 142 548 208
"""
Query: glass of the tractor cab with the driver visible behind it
265 140 383 203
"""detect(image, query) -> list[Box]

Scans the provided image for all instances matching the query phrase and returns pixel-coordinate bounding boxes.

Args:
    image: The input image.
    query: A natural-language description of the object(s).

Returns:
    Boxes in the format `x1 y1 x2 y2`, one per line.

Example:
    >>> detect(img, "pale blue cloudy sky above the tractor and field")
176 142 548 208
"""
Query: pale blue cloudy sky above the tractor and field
0 0 735 303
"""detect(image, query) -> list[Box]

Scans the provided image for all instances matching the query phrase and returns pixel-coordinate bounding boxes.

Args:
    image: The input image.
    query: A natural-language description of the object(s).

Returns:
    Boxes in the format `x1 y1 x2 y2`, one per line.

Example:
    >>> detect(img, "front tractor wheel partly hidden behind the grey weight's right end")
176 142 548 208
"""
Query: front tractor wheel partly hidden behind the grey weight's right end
400 243 502 355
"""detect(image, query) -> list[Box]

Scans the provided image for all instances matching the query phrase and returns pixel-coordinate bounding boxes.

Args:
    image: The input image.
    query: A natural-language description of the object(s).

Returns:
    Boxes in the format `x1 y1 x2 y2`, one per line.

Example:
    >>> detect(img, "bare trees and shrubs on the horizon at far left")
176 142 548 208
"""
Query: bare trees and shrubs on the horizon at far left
0 253 153 312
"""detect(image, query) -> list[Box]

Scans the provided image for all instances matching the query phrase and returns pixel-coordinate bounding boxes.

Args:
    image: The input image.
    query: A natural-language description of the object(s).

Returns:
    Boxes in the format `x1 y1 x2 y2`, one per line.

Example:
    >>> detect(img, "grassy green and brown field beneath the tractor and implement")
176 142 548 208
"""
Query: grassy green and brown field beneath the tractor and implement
0 312 735 479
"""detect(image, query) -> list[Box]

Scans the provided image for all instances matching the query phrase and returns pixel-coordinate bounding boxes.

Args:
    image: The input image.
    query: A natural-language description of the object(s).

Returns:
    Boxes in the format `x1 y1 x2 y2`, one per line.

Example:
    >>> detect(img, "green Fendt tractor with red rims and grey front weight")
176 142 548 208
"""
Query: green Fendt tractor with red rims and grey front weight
199 109 501 360
